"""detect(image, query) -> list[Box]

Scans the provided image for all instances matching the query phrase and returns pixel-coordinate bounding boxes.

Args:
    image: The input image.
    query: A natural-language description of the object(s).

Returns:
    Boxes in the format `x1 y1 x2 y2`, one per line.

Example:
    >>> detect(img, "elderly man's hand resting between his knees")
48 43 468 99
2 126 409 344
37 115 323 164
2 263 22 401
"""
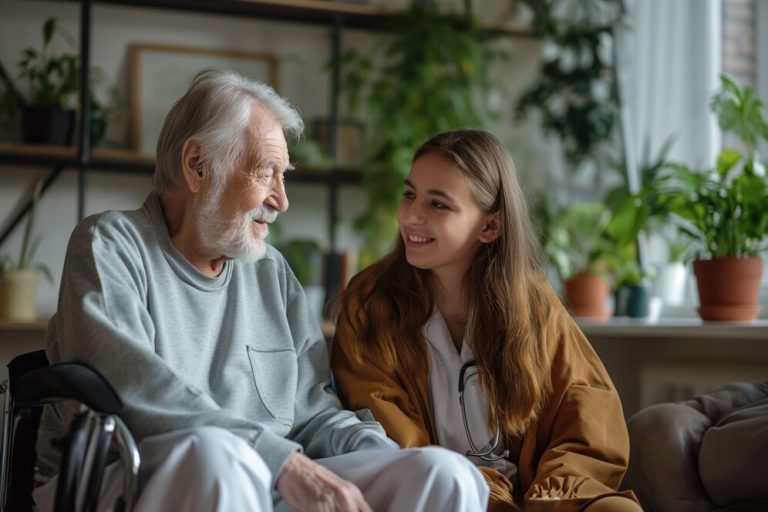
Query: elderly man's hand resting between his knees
277 452 373 512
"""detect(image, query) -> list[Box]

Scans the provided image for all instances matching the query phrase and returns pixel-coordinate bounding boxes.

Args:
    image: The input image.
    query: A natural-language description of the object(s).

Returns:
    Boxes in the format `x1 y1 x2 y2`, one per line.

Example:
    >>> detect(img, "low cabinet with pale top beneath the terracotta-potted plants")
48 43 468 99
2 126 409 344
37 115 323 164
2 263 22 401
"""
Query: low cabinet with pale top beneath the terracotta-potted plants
579 318 768 417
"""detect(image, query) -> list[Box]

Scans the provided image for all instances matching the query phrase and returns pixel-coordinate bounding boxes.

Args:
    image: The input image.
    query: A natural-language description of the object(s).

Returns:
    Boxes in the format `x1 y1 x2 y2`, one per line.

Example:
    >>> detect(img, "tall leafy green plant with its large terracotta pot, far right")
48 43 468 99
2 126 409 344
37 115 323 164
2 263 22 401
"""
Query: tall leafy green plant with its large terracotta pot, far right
668 75 768 321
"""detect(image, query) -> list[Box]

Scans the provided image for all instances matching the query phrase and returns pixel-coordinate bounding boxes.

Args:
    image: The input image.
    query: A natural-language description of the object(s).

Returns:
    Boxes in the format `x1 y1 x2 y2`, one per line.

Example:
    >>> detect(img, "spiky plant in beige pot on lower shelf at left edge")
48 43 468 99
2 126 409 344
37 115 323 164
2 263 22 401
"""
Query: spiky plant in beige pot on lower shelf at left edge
0 181 53 322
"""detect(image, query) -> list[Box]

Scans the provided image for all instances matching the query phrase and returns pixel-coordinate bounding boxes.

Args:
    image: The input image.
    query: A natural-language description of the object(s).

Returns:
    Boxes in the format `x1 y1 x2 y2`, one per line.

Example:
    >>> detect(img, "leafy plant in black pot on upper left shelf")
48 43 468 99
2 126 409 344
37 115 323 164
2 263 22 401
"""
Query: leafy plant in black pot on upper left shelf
0 18 107 145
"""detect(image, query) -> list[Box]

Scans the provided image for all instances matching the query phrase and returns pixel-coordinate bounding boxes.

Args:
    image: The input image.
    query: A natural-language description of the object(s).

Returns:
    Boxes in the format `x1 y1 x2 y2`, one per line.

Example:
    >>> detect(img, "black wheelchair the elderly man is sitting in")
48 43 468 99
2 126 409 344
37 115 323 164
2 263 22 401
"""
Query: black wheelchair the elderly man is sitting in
0 350 140 512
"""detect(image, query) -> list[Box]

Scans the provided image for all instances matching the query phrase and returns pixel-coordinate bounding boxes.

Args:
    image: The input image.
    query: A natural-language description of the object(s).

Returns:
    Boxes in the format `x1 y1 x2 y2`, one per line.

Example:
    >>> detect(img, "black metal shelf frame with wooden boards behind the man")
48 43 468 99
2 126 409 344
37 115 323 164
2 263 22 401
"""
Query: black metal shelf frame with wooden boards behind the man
0 0 378 252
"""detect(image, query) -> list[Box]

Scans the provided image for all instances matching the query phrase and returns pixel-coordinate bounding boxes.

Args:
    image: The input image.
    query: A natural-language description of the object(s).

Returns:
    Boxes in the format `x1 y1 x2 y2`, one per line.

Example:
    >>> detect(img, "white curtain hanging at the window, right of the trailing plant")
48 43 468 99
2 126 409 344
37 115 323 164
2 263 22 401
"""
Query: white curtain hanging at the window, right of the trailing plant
616 0 721 180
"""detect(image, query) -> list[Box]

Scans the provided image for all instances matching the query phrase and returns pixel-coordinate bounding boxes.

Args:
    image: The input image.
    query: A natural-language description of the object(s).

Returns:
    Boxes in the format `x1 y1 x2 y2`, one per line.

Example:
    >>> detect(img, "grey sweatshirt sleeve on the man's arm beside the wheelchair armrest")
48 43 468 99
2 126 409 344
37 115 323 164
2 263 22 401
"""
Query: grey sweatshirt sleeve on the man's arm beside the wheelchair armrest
47 221 301 477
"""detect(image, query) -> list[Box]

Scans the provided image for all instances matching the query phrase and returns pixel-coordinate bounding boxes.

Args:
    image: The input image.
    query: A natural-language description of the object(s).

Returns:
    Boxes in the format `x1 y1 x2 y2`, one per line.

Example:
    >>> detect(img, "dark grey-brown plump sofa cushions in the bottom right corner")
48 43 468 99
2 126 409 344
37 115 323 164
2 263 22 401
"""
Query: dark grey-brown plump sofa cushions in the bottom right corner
622 382 768 512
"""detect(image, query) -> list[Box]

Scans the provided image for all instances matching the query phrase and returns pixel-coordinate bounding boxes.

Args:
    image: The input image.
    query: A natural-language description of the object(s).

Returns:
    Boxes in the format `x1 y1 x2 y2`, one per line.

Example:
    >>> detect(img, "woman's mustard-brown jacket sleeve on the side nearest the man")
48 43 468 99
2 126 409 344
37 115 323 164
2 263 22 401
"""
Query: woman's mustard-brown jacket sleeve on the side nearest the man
331 292 430 448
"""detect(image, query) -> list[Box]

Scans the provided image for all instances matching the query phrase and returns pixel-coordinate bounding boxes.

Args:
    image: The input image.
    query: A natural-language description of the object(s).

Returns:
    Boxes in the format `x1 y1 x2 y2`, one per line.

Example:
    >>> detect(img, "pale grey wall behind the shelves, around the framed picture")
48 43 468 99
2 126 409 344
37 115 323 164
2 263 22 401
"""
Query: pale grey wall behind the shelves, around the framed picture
0 0 553 320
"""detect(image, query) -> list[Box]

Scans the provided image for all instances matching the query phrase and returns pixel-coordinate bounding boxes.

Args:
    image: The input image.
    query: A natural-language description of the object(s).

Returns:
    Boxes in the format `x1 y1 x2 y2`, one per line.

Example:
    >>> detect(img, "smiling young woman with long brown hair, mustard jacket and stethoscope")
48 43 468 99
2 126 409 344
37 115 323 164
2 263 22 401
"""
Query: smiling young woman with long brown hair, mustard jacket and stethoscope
332 130 641 512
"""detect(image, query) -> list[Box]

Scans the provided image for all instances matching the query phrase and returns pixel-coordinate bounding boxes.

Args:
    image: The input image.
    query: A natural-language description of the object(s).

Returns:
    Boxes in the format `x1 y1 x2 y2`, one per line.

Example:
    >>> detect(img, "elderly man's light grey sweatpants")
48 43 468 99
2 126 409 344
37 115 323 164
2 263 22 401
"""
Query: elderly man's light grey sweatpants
34 427 488 512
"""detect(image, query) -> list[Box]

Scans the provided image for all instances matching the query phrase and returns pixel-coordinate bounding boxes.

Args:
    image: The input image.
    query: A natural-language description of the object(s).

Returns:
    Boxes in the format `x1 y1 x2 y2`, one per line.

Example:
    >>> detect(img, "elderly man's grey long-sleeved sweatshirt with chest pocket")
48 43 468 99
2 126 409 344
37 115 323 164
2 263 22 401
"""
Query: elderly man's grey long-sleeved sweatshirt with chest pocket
38 194 393 483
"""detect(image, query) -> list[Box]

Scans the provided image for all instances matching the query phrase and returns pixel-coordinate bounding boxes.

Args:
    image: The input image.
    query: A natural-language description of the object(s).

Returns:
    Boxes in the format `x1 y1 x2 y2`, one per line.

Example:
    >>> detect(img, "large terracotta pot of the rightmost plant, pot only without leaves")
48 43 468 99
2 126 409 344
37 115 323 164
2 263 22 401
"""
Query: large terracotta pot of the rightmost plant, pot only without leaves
693 257 763 322
